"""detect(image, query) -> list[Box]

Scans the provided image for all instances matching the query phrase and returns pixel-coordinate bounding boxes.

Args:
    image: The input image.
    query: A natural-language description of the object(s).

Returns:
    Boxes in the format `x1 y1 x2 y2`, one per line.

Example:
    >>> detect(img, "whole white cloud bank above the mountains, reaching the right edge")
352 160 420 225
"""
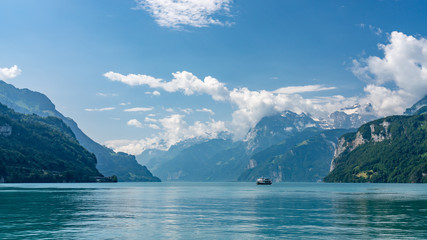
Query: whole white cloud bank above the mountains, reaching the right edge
104 32 427 154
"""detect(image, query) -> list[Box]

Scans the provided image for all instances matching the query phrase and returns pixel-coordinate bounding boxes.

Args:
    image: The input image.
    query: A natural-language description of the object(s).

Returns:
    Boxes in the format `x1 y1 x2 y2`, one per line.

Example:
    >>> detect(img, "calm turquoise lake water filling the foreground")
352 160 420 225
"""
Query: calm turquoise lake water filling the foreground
0 182 427 239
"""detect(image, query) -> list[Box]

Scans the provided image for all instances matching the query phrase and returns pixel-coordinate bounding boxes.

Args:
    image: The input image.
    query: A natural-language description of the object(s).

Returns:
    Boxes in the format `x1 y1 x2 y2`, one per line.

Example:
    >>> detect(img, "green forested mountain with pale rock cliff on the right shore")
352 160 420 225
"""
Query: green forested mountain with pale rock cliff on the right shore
324 113 427 183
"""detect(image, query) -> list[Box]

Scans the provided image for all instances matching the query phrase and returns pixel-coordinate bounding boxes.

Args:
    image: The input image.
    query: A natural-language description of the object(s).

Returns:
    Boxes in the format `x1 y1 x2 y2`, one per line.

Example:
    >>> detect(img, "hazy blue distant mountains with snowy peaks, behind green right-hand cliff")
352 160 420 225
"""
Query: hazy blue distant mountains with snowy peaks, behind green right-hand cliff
137 105 373 181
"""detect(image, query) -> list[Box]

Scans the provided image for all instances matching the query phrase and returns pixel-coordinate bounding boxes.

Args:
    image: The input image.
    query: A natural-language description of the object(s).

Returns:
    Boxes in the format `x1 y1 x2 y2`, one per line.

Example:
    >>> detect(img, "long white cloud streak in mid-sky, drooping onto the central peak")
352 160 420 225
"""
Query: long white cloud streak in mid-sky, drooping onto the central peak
104 71 335 139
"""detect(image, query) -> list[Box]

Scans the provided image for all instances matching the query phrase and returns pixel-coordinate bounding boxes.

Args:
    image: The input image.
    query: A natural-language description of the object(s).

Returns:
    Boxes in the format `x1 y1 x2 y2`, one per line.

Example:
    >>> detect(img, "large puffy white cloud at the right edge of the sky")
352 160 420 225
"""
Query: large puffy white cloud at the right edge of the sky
352 32 427 116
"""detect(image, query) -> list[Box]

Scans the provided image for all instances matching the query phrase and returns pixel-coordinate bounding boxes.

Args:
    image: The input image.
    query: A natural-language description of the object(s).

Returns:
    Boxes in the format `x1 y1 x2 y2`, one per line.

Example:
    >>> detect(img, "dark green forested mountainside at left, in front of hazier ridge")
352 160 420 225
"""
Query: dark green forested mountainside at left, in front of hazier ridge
0 104 103 182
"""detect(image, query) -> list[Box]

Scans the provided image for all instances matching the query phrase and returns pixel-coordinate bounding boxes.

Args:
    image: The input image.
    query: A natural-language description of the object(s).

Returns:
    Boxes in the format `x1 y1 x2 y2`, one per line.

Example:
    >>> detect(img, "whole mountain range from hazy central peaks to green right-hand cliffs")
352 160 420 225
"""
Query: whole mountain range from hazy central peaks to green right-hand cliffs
137 96 427 182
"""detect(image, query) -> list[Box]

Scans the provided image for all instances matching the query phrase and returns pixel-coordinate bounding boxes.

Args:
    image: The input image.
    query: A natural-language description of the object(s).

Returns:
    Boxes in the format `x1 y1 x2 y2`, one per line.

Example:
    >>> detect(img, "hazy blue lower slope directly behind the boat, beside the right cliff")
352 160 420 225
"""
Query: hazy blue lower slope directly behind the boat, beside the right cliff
238 128 350 182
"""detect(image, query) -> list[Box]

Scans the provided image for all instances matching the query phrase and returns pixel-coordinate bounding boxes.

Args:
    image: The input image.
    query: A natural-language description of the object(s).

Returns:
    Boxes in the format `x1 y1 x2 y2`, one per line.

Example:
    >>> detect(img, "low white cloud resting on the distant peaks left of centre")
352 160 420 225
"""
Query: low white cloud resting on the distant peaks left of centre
105 114 228 155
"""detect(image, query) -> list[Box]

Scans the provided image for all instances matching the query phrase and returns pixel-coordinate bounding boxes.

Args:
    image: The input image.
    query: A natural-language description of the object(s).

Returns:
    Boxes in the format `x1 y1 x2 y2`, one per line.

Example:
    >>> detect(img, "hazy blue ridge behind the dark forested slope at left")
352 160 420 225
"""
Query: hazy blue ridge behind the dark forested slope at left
0 81 160 182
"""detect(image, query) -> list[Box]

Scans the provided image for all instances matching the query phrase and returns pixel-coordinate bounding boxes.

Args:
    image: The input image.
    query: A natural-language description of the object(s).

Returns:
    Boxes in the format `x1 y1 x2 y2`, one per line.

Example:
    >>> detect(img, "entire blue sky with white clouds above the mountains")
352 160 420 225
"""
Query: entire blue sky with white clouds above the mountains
0 0 427 154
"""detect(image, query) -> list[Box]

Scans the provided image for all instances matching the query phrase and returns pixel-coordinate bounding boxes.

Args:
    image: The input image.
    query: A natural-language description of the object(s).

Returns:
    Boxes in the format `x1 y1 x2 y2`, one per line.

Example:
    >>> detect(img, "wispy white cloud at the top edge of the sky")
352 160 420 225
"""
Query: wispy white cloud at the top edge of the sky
136 0 232 29
